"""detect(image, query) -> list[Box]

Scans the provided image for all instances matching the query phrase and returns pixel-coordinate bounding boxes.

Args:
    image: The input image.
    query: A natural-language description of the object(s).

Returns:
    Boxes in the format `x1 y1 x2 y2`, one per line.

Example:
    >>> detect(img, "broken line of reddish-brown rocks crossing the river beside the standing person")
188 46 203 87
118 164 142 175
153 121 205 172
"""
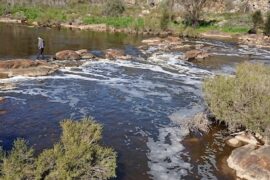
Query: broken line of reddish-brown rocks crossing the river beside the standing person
0 36 210 79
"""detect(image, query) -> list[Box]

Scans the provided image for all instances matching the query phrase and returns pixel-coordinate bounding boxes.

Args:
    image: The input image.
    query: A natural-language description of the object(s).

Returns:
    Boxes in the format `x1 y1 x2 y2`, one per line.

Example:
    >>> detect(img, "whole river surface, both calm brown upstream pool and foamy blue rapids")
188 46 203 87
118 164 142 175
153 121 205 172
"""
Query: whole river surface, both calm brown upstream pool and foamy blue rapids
0 24 270 180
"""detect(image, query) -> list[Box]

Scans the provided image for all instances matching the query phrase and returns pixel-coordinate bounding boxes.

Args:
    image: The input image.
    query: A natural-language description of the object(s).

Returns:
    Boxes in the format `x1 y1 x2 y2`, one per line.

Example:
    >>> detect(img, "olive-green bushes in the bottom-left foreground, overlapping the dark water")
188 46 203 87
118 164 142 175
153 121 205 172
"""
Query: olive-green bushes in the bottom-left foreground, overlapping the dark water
0 119 116 180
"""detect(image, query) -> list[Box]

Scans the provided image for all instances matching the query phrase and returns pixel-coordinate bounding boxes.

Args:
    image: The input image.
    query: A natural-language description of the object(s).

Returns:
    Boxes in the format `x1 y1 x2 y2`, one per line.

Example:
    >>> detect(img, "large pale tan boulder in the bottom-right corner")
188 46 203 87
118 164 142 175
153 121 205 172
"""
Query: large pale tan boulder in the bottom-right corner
227 145 270 180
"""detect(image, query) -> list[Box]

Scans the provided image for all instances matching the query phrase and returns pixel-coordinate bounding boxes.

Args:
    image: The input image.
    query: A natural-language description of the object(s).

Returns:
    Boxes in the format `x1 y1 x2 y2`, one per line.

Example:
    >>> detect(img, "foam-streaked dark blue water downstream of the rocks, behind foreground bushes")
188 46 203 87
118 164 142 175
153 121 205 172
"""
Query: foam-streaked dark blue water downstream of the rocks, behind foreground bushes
0 54 208 179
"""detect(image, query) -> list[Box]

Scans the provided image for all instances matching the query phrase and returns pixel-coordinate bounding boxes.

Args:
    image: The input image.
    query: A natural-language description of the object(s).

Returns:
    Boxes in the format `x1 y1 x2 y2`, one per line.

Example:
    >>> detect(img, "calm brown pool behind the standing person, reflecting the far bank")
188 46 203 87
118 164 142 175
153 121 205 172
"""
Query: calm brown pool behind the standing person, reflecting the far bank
0 23 141 59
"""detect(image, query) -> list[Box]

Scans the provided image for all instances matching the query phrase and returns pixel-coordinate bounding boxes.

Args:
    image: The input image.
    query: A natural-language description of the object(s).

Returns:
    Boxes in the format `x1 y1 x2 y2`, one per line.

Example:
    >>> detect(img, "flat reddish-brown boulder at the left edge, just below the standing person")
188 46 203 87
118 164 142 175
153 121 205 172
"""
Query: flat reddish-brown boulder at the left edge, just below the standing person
0 59 56 78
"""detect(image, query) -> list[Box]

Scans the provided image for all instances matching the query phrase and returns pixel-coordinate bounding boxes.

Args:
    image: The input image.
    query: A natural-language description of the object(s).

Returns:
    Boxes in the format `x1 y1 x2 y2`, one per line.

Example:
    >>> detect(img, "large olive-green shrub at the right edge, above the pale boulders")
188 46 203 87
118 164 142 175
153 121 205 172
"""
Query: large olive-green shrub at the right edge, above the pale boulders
204 63 270 137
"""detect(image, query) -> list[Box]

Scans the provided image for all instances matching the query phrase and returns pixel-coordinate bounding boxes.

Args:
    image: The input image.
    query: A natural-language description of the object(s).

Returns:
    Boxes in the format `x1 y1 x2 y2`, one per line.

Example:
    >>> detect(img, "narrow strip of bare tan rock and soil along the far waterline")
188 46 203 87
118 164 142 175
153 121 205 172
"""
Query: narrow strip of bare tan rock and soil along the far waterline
0 17 270 48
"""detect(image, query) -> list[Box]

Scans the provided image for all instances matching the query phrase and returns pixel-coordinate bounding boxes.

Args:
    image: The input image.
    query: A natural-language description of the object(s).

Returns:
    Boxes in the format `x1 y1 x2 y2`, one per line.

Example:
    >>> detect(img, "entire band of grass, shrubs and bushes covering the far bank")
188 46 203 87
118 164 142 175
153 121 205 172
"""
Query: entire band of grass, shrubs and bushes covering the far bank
0 0 262 36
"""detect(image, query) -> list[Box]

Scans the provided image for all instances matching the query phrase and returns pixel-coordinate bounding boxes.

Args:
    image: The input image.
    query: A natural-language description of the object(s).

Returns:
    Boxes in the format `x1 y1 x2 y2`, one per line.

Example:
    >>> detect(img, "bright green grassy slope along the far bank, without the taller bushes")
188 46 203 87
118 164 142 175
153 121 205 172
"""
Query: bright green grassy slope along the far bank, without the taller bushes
0 3 252 36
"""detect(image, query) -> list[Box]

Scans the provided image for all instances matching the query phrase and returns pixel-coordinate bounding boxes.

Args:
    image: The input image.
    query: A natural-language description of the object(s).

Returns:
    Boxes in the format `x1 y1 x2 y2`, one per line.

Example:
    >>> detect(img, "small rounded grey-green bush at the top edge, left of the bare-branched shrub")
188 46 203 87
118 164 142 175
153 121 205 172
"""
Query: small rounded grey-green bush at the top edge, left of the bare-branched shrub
104 0 125 17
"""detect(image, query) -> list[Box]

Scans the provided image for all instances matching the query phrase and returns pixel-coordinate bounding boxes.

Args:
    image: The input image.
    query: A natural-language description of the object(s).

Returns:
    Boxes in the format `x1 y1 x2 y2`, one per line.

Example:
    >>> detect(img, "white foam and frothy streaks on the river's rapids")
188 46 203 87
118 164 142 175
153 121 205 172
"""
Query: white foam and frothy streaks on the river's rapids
0 42 270 180
